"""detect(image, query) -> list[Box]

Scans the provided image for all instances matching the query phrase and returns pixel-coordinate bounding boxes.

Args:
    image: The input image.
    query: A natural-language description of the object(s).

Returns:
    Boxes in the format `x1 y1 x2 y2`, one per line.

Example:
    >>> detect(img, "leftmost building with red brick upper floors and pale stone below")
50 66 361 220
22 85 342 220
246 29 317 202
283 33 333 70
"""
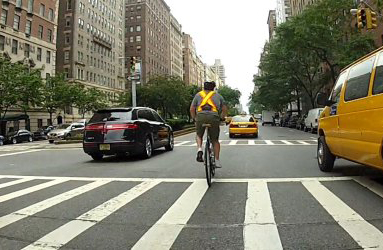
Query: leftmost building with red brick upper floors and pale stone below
0 0 59 134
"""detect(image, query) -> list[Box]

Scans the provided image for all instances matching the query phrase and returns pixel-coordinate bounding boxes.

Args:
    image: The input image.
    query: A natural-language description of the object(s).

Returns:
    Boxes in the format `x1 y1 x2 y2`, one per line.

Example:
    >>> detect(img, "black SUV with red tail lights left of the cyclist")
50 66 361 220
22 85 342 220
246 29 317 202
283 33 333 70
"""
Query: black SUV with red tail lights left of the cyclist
83 107 174 160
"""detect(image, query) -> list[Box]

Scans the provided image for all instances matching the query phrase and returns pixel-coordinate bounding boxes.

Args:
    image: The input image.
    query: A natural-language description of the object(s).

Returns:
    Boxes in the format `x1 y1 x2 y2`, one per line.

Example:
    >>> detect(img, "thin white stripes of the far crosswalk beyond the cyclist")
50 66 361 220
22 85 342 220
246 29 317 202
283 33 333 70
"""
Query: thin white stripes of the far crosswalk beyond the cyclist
174 140 317 147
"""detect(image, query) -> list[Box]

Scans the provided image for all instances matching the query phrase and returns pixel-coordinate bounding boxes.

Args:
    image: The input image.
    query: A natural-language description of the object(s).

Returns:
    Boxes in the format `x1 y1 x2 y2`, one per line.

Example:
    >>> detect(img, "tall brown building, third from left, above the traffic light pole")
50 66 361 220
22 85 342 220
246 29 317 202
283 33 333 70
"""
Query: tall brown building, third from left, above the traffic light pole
125 0 171 83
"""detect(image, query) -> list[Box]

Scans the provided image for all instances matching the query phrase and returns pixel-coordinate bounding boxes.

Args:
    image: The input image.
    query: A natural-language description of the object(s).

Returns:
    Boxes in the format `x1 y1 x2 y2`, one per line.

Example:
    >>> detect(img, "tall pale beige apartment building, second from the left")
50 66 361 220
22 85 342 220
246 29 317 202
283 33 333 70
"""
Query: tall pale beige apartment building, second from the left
57 0 125 122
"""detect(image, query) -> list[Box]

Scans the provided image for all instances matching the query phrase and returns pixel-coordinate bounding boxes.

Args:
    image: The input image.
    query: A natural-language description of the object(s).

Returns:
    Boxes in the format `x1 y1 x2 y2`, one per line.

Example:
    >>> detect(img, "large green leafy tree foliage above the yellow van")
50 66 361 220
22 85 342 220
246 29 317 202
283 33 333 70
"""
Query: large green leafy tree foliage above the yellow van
250 0 375 111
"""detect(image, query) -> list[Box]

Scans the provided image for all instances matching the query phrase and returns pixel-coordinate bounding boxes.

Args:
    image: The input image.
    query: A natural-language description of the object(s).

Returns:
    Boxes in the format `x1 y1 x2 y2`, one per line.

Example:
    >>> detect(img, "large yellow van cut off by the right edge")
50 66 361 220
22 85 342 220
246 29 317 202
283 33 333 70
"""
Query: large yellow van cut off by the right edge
317 47 383 172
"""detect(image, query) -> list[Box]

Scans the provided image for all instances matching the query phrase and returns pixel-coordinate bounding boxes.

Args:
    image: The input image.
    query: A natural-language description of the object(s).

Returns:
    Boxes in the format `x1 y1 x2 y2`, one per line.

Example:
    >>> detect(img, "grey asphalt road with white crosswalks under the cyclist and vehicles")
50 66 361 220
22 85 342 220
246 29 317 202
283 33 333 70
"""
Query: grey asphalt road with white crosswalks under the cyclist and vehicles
0 126 383 250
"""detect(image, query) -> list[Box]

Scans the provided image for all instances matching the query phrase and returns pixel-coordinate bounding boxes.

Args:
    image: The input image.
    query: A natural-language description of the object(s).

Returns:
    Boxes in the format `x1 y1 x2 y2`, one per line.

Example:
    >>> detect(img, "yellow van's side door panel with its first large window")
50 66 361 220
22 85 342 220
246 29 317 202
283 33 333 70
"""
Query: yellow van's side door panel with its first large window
338 56 376 163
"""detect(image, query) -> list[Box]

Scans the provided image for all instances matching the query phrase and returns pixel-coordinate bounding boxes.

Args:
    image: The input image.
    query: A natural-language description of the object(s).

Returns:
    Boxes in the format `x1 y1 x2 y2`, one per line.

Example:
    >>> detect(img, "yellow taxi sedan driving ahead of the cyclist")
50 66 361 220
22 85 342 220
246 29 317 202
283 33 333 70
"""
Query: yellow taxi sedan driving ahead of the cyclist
229 115 258 138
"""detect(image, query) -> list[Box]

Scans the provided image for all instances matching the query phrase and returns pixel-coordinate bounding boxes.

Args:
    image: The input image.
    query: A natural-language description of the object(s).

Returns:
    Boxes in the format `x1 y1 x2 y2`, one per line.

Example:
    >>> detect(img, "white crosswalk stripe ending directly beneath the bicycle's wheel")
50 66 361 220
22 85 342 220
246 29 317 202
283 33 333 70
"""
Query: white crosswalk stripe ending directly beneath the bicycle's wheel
132 180 208 250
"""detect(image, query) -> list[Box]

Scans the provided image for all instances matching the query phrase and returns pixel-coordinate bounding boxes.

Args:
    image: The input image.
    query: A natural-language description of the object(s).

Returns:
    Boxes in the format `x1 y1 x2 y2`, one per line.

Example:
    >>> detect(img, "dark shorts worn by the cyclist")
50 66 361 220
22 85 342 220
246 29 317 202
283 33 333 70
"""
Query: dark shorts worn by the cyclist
196 113 221 142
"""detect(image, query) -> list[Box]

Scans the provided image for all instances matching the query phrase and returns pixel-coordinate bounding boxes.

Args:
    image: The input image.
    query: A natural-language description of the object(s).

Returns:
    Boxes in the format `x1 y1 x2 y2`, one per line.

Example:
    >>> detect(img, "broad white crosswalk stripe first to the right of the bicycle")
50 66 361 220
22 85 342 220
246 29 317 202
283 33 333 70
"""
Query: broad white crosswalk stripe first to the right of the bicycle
243 181 283 250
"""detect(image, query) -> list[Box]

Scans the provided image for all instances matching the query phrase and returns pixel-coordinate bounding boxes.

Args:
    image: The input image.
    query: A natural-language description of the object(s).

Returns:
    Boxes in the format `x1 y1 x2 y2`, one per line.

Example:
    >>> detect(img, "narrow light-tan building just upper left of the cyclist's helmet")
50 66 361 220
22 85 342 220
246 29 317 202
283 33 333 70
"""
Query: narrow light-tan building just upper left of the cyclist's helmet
182 33 199 85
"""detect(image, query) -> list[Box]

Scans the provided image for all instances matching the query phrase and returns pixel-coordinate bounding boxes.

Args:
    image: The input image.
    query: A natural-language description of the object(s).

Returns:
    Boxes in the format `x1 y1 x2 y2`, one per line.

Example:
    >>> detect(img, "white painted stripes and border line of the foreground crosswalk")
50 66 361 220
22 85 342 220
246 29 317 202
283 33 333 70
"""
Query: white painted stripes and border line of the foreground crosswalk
0 175 383 250
